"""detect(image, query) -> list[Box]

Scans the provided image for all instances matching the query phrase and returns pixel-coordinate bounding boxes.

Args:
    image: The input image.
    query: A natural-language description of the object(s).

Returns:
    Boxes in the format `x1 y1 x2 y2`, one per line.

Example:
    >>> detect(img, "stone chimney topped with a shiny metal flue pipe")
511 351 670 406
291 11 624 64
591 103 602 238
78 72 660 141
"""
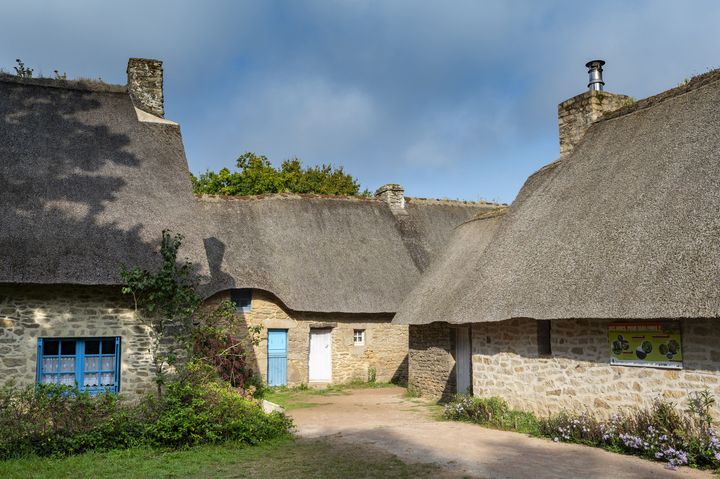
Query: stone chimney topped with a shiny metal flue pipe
558 60 633 158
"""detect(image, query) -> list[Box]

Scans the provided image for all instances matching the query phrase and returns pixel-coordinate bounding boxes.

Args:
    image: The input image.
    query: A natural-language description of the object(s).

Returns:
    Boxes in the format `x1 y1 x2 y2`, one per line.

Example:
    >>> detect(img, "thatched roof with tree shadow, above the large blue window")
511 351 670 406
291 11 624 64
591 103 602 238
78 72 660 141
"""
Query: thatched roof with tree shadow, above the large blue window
0 76 207 284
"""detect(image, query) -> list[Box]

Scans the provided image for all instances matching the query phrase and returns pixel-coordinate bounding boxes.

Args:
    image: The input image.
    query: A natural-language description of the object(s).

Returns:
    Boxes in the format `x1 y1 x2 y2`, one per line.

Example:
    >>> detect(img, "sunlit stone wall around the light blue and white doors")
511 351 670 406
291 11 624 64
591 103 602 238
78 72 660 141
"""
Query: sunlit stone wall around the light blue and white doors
206 290 408 386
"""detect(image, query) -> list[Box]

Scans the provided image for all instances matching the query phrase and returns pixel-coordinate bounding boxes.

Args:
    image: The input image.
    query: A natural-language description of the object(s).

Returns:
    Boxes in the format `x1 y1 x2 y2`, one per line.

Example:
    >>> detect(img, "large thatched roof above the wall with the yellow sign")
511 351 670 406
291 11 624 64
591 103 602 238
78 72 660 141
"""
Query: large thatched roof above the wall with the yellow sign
396 72 720 323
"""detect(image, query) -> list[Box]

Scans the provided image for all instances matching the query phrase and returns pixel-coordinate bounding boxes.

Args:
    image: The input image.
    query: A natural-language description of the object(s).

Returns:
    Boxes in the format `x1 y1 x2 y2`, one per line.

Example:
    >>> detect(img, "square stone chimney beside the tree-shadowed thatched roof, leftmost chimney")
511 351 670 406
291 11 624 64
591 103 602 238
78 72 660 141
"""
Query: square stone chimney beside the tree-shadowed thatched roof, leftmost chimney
127 58 165 118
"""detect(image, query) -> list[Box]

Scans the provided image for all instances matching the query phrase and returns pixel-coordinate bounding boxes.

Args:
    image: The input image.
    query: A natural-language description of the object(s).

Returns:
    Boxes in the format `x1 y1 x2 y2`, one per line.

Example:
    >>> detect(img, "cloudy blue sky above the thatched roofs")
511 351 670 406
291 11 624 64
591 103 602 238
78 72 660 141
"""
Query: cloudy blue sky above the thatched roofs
0 0 720 202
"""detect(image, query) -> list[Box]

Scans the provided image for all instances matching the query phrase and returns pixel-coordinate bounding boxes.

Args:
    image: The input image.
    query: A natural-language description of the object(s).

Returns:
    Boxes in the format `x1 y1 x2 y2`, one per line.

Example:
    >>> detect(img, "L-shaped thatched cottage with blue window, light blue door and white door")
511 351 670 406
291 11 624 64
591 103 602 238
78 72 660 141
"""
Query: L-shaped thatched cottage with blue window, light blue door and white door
0 59 496 395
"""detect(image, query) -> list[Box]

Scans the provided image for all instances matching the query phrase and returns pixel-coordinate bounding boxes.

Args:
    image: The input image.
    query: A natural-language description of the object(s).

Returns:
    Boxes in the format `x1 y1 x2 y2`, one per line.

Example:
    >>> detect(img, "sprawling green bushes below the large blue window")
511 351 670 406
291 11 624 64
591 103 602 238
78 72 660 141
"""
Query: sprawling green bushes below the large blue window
0 374 292 459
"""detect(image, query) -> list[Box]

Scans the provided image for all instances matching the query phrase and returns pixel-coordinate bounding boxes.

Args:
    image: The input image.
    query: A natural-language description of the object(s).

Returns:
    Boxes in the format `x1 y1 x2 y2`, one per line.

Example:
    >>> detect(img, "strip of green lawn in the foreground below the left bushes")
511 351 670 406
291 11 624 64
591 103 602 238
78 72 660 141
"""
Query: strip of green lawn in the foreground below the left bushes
0 439 442 479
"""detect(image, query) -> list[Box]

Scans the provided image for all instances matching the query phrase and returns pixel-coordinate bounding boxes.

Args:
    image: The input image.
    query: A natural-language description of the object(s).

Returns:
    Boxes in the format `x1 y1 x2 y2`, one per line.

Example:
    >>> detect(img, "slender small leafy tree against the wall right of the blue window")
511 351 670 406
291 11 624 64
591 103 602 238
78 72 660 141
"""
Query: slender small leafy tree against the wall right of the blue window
120 230 202 395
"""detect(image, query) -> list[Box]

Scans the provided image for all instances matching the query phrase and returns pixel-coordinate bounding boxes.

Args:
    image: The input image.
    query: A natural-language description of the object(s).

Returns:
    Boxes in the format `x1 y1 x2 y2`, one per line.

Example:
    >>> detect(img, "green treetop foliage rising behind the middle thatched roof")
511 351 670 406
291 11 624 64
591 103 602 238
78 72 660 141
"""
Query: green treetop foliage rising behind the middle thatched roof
192 152 370 196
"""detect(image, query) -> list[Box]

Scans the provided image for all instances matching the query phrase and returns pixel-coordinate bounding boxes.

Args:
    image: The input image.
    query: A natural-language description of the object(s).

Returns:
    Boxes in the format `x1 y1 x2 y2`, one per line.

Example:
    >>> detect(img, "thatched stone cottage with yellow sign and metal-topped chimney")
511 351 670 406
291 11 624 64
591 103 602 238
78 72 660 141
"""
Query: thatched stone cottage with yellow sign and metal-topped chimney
393 65 720 414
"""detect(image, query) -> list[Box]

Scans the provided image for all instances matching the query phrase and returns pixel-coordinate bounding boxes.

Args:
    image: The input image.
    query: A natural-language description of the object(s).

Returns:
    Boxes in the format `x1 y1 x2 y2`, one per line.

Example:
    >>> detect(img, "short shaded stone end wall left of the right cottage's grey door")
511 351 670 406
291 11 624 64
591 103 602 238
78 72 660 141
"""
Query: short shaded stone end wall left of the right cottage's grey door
408 323 456 399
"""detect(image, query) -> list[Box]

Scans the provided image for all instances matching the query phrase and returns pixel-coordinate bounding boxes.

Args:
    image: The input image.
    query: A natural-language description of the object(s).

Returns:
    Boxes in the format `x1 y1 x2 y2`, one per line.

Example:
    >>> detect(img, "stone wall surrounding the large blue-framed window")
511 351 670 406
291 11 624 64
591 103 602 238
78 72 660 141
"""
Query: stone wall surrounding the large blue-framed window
0 285 155 397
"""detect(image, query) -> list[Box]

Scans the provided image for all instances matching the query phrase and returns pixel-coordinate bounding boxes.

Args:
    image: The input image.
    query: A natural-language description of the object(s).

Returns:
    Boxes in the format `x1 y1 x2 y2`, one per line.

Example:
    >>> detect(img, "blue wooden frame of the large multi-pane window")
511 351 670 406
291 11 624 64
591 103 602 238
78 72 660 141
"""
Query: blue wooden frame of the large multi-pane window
35 336 122 395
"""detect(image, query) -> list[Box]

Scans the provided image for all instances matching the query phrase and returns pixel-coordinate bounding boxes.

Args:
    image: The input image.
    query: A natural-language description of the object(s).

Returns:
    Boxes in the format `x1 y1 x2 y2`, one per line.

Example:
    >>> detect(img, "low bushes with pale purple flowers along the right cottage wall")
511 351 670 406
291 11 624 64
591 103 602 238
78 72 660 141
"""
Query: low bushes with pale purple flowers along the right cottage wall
444 391 720 469
